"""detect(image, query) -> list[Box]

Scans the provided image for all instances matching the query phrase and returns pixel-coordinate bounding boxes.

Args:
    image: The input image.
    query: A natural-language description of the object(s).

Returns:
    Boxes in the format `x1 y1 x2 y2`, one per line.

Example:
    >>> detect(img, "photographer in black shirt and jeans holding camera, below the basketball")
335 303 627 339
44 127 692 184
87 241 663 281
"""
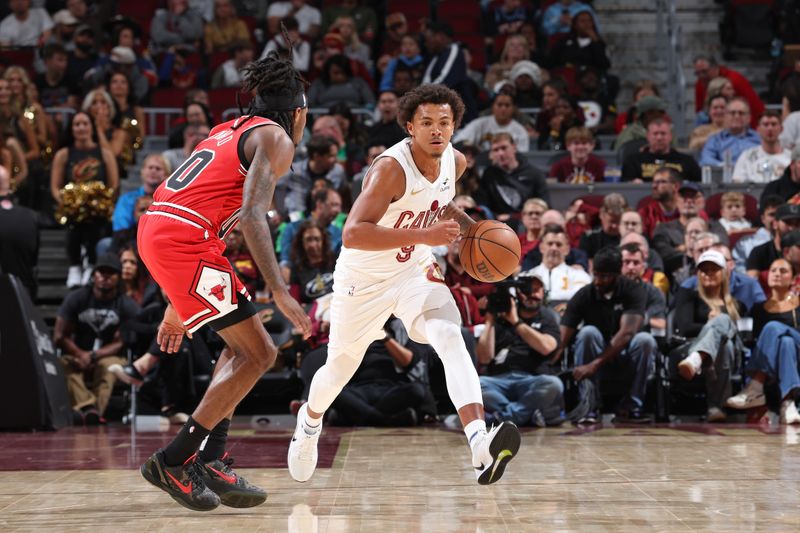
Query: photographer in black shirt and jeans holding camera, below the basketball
477 275 564 426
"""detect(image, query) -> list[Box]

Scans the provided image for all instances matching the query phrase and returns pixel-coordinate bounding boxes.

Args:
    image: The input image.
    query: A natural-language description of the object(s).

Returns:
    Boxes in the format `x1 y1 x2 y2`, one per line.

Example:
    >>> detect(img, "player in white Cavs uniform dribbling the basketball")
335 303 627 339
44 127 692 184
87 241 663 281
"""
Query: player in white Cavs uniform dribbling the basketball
288 85 520 485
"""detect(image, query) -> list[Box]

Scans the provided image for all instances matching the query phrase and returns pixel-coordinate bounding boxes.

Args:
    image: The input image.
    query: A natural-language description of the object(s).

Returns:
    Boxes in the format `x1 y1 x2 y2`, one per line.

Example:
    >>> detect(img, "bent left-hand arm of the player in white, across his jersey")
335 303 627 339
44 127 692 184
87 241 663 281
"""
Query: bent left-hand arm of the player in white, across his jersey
342 157 459 251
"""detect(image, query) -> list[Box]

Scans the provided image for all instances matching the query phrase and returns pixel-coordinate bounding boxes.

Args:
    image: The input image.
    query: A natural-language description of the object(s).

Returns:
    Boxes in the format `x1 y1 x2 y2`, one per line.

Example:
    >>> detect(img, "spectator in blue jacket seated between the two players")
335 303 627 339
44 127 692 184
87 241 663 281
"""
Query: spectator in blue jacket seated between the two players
279 188 342 283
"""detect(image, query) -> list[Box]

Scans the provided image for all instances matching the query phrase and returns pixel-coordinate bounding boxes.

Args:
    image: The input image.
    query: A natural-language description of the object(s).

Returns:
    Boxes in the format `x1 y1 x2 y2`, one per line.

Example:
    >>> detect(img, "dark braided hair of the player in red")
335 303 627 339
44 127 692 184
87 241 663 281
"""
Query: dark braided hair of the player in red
233 24 308 137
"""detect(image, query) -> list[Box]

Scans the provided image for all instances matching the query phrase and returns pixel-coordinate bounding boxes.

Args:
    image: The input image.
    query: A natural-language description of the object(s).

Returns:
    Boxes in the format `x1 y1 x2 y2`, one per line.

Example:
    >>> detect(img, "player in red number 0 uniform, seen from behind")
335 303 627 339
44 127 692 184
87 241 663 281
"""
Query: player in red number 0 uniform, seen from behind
138 52 311 511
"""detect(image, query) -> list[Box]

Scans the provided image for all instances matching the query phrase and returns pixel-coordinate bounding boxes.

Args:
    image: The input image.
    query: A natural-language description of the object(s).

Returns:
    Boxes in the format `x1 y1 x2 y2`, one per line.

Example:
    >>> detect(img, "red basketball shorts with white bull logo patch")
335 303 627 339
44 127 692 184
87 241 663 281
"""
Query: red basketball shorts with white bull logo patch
137 211 256 333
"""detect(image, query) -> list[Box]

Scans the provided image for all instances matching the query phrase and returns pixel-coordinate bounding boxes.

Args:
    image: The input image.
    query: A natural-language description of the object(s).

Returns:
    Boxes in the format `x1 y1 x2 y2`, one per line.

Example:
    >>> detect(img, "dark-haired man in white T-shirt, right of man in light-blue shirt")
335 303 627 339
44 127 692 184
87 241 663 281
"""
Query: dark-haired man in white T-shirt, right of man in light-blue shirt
733 109 791 183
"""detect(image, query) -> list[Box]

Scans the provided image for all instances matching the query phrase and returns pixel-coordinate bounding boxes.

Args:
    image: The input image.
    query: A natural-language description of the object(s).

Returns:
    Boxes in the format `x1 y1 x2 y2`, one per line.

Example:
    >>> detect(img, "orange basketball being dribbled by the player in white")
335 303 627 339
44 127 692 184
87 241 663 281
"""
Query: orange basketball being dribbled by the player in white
459 220 520 283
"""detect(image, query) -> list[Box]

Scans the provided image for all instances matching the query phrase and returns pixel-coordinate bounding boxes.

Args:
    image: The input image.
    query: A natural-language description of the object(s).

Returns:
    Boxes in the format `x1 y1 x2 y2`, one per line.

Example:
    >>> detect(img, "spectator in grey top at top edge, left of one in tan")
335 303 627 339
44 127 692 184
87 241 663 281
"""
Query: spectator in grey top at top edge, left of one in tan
150 0 203 54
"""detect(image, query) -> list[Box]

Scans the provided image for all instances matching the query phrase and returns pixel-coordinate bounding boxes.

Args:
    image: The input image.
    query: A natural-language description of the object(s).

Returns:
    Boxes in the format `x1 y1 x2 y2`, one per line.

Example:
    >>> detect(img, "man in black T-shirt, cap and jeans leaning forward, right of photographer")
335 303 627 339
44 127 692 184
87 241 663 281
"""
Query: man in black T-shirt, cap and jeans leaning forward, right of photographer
561 247 657 423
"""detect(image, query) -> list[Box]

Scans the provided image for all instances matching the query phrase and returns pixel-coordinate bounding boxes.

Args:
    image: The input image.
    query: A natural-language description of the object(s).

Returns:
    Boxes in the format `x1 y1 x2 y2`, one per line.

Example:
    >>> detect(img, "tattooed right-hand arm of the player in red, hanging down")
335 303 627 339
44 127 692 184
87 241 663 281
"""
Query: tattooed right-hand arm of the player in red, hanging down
239 127 311 337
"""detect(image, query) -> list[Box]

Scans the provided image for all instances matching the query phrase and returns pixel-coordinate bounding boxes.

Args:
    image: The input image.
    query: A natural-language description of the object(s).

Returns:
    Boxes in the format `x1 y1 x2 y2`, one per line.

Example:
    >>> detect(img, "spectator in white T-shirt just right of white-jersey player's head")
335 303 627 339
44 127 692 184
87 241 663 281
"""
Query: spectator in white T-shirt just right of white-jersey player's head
453 93 530 152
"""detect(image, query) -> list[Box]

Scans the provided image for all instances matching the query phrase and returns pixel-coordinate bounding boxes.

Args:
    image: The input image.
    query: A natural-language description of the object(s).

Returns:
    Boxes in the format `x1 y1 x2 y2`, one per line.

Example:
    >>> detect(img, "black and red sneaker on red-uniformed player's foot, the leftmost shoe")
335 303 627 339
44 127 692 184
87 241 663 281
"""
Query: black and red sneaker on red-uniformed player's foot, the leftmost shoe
139 450 220 511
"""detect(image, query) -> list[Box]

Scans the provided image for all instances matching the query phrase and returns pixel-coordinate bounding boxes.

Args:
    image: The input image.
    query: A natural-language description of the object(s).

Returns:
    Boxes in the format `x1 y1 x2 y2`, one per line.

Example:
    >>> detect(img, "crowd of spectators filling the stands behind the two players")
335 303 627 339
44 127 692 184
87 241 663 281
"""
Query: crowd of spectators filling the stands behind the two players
0 0 800 426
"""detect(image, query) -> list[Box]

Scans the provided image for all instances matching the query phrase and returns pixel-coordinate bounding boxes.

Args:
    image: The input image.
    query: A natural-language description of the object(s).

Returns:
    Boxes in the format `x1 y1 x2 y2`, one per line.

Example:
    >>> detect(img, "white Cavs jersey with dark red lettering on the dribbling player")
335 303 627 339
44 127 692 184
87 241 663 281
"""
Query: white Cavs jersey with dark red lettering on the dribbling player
336 138 456 279
